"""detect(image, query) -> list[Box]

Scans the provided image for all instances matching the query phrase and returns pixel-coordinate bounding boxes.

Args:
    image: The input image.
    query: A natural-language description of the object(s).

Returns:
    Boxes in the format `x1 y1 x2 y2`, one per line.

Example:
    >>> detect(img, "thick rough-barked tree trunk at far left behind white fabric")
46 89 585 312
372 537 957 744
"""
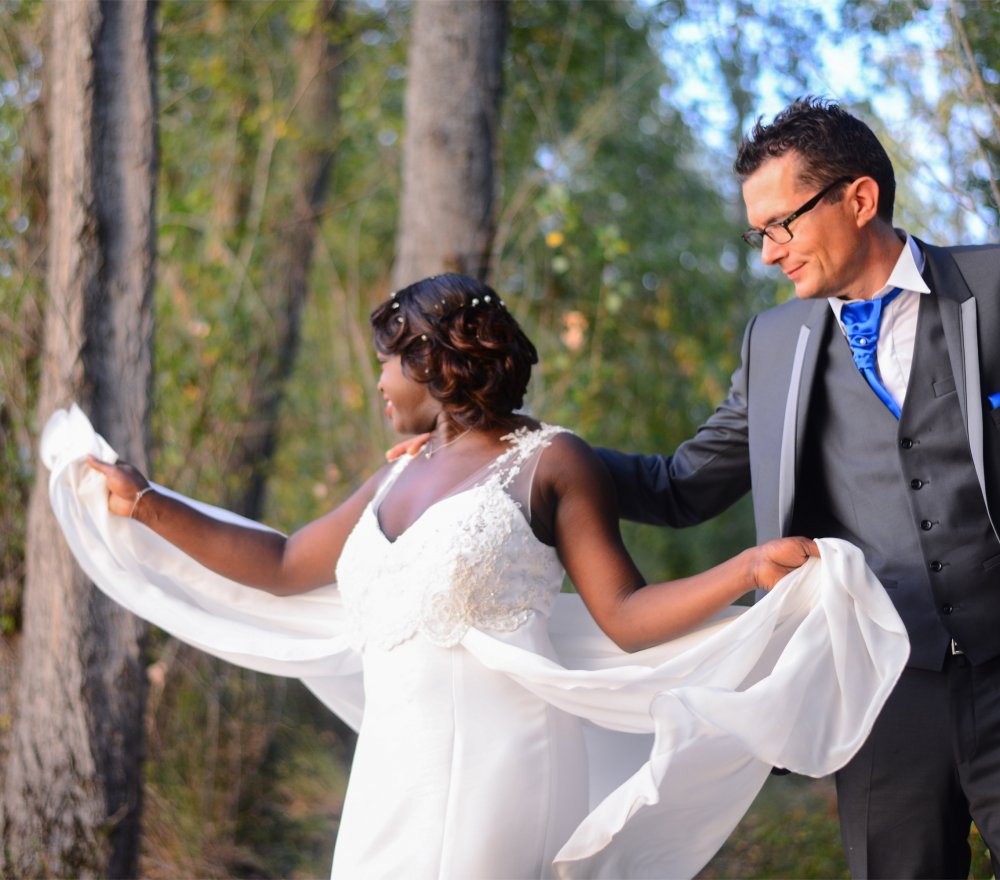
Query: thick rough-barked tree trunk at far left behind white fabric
0 0 156 877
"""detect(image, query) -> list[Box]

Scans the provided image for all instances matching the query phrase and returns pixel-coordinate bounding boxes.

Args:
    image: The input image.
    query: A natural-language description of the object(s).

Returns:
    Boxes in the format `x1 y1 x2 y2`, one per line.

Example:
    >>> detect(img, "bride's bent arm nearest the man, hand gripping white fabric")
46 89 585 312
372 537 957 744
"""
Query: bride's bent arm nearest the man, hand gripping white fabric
536 435 819 651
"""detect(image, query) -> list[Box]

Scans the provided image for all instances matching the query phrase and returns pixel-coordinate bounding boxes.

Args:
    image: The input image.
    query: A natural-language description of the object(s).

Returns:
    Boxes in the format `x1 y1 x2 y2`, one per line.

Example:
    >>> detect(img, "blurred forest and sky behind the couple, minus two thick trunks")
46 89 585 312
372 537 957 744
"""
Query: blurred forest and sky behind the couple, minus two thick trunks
0 0 1000 878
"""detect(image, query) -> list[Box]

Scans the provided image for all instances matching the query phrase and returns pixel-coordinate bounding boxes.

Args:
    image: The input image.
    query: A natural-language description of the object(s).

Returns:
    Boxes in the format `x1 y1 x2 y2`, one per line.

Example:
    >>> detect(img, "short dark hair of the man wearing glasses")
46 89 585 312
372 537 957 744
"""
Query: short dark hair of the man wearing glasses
733 95 896 223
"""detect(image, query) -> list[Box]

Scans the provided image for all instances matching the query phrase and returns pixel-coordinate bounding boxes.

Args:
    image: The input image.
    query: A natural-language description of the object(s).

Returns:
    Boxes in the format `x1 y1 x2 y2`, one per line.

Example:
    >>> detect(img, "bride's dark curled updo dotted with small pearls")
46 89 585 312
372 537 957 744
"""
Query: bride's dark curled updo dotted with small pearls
370 275 538 428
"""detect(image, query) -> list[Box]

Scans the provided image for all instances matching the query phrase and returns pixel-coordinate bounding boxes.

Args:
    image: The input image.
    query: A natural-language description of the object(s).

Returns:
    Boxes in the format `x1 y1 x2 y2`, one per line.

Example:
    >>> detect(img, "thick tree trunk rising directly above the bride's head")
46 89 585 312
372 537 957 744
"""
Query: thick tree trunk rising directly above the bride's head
393 0 507 288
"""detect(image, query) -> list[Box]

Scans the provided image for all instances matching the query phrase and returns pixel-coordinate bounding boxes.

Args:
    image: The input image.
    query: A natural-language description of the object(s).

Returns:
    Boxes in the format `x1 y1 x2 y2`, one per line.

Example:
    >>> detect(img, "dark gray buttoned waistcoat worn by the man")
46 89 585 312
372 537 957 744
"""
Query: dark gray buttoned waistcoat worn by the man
793 295 1000 669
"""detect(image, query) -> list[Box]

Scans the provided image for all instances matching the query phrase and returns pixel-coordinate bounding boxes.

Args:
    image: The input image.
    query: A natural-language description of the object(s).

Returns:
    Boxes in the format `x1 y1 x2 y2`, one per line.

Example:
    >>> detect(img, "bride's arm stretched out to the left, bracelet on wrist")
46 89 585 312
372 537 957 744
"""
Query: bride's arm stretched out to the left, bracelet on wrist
88 457 382 595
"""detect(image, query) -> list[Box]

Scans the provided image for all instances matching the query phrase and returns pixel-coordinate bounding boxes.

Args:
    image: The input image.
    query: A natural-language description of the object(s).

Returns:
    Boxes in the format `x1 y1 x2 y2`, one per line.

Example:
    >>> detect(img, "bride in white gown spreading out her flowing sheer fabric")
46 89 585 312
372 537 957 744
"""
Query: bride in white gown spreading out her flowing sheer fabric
42 275 908 880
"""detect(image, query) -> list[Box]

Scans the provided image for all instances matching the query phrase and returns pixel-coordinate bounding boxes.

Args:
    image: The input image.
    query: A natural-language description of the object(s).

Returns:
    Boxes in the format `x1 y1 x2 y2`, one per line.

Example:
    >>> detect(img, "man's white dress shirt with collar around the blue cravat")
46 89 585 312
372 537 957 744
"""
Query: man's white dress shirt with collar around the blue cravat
828 232 931 409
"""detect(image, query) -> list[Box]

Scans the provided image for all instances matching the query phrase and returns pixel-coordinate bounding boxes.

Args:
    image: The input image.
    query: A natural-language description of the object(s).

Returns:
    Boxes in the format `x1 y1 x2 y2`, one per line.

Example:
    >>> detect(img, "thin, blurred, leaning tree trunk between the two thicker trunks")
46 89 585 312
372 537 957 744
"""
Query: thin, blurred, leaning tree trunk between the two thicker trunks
227 0 341 519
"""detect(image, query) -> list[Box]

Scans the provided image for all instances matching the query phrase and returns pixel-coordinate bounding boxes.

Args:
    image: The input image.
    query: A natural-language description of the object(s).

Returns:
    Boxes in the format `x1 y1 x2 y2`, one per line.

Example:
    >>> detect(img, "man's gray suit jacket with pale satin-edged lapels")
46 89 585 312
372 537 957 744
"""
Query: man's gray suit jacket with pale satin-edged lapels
599 237 1000 541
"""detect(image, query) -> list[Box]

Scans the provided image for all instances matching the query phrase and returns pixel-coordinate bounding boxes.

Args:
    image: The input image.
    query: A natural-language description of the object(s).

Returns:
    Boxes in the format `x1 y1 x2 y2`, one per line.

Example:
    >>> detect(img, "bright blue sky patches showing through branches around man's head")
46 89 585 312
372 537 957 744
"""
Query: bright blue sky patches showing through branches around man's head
664 0 1000 243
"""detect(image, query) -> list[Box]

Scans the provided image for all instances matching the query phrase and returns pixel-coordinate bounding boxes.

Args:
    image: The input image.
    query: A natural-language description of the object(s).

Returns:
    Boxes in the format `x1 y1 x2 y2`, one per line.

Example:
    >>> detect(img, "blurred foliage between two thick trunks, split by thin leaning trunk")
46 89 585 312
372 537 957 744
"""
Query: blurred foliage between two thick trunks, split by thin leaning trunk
155 3 405 516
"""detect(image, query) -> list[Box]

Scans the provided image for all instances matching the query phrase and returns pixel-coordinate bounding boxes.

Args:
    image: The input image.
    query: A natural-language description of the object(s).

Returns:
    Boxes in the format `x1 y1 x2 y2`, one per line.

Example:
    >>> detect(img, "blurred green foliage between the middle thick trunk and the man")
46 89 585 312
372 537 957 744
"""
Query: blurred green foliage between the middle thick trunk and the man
495 2 774 578
